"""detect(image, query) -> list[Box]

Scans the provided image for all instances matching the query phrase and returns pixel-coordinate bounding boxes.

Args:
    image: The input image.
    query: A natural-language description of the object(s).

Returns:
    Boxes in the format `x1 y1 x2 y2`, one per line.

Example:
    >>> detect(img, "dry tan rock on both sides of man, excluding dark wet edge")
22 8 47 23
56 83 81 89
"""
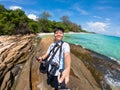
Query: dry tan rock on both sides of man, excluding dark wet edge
0 35 102 90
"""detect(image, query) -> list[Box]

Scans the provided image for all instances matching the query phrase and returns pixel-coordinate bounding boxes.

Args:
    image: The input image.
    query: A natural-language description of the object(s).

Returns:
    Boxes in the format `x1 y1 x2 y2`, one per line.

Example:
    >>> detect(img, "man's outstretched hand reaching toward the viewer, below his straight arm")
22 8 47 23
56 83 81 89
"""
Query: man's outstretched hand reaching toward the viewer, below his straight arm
58 69 69 84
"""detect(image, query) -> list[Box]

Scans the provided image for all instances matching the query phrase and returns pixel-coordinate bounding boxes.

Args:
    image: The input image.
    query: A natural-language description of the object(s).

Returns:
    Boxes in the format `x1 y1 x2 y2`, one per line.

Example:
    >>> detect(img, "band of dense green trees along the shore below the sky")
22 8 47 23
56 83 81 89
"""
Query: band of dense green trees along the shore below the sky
0 5 86 35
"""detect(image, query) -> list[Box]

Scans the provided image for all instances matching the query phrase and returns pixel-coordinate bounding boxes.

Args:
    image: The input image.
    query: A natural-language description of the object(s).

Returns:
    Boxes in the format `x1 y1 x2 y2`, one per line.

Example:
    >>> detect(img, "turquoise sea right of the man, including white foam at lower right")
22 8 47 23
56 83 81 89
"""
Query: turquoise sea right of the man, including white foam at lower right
63 34 120 90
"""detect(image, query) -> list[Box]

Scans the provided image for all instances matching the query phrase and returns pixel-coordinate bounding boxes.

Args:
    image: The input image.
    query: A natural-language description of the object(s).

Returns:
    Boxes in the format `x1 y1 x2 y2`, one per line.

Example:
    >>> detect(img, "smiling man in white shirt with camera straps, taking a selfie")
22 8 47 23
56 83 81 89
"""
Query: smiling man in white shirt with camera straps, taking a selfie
38 27 71 90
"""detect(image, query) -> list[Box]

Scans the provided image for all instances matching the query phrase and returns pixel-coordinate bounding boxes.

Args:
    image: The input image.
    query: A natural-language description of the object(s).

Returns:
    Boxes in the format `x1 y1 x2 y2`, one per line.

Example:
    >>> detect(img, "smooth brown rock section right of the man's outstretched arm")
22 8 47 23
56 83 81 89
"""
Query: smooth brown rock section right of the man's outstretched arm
69 54 100 90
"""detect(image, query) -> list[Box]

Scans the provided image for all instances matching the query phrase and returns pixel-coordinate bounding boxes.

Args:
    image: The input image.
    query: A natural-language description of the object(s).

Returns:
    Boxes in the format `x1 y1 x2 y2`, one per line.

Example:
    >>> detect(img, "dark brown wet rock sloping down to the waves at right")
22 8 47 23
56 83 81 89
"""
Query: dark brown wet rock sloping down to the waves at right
70 44 120 90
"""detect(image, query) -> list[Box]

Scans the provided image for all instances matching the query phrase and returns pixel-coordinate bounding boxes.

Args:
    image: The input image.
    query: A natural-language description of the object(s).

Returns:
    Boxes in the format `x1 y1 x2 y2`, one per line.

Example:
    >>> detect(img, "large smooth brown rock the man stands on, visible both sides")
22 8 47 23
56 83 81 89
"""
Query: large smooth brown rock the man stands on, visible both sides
31 37 100 90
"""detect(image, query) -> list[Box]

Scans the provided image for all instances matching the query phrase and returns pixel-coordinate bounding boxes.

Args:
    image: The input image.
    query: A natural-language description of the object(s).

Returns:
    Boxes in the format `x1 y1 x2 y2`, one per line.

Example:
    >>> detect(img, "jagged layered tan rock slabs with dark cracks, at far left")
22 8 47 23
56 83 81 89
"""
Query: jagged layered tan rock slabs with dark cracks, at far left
0 35 34 90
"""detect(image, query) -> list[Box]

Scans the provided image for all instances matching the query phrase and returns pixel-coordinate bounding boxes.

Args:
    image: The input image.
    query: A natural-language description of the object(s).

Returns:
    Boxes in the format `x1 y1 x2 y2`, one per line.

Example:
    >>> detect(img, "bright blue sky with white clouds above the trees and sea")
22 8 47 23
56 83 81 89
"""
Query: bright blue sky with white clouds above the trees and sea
0 0 120 36
